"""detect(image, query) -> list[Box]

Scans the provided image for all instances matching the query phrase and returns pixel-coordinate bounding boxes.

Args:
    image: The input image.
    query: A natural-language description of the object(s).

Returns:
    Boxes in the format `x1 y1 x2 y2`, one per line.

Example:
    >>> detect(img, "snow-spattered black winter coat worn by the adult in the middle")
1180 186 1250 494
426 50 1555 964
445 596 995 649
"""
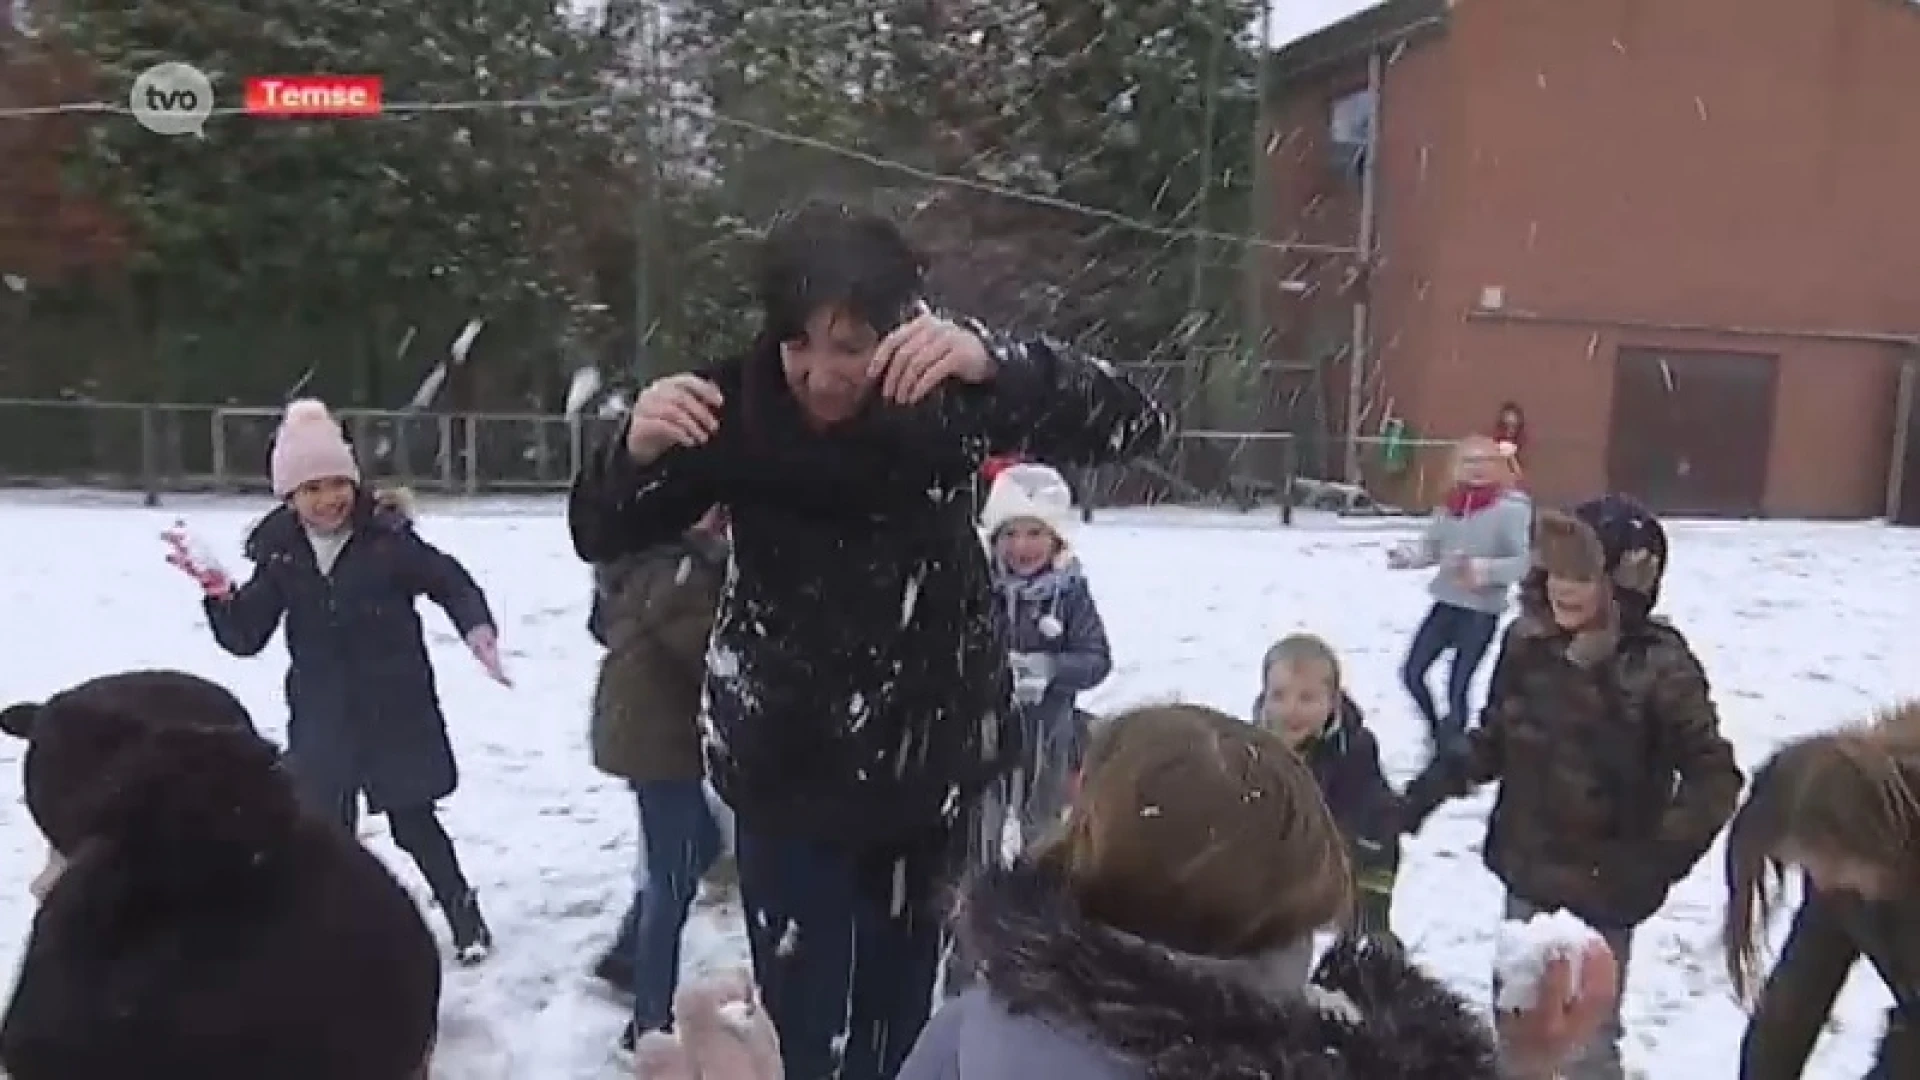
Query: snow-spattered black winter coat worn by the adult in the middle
568 334 1167 851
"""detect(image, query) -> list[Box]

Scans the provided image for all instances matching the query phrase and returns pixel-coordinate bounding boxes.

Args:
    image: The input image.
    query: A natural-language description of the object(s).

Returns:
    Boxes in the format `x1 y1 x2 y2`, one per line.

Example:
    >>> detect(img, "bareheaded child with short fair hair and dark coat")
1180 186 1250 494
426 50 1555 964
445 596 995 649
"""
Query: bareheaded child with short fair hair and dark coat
1254 634 1400 932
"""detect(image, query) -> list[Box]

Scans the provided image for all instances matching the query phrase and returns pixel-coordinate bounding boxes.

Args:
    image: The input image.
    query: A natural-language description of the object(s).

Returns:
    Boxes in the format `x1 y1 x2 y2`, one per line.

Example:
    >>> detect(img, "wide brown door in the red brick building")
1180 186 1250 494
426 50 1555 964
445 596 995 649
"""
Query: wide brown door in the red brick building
1607 348 1780 517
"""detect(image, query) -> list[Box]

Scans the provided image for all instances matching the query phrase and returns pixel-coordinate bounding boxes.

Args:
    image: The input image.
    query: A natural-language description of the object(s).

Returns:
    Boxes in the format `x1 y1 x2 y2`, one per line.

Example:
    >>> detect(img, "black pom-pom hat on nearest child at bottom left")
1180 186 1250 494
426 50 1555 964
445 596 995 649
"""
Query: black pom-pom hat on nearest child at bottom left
0 717 440 1080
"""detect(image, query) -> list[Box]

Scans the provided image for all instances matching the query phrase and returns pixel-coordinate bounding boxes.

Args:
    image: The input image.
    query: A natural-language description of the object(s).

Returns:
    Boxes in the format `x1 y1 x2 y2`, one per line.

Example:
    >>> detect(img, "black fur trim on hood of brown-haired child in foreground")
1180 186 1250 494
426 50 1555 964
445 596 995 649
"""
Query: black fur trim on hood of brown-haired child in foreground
944 863 1498 1080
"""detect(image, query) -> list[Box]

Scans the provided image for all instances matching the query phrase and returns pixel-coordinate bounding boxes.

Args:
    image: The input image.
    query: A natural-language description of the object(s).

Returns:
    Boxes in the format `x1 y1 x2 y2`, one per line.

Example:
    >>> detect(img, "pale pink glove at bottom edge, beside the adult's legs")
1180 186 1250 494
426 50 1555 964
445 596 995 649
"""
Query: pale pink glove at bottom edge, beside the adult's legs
634 972 781 1080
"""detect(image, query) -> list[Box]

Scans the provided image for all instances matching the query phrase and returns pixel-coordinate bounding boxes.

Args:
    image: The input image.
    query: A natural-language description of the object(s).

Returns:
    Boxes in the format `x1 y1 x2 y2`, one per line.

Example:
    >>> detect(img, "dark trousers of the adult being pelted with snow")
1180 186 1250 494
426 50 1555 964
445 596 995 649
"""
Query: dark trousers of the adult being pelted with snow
735 821 954 1080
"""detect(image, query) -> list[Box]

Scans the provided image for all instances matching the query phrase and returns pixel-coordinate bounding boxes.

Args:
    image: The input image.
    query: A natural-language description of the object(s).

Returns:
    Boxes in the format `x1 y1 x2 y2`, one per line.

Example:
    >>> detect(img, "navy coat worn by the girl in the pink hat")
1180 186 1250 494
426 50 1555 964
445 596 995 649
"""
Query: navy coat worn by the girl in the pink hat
205 494 493 817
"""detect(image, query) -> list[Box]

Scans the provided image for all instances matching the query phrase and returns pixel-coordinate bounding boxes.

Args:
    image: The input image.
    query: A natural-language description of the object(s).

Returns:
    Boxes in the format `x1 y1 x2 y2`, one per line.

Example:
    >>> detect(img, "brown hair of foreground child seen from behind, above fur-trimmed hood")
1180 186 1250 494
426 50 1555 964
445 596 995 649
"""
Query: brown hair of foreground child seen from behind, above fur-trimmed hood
1035 705 1354 957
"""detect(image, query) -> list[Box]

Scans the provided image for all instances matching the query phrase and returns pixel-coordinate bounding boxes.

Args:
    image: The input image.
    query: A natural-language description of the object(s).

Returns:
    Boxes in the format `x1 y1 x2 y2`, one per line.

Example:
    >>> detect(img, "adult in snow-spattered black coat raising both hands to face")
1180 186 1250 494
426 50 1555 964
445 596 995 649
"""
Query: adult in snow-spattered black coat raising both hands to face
568 206 1167 1080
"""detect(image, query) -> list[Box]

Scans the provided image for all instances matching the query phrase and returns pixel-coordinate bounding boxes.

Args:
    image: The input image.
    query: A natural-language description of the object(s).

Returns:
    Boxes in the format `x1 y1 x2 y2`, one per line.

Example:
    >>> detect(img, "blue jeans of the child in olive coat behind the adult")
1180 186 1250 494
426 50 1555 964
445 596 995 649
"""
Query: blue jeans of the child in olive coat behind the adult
628 780 720 1032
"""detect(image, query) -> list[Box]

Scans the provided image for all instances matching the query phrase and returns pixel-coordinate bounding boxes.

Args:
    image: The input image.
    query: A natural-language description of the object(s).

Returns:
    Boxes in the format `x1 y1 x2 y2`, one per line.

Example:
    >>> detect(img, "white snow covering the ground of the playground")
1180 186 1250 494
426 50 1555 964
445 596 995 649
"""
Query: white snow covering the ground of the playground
0 496 1920 1080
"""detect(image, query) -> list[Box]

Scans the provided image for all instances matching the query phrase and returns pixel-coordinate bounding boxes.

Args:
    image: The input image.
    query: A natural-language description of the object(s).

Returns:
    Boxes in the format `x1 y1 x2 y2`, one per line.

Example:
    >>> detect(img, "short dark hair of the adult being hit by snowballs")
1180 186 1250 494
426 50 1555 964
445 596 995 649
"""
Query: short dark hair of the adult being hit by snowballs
756 202 925 342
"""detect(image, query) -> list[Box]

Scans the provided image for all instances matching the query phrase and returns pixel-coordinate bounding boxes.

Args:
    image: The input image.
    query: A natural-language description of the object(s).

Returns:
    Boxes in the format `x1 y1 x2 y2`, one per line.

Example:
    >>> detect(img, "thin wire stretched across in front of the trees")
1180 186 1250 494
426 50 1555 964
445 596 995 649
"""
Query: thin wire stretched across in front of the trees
0 90 1359 256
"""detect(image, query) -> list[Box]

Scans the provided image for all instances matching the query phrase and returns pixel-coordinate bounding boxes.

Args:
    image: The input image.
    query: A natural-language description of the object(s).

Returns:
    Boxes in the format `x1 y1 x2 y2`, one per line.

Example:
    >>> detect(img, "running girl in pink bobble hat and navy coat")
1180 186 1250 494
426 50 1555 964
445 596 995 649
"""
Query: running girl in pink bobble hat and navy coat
167 400 507 963
